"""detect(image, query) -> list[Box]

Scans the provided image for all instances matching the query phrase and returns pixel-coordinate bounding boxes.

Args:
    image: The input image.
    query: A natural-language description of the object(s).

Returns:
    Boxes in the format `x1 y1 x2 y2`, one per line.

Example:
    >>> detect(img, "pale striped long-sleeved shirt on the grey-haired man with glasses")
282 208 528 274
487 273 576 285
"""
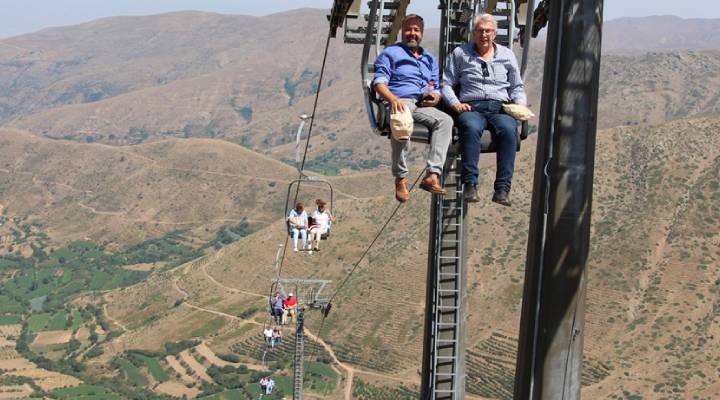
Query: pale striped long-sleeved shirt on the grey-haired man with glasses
442 43 527 106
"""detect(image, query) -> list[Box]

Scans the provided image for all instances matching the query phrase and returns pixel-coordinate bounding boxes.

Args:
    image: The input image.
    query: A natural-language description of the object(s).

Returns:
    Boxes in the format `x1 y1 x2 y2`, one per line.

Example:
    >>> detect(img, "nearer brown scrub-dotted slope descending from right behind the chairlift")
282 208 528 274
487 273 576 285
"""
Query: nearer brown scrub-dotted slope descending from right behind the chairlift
101 118 720 399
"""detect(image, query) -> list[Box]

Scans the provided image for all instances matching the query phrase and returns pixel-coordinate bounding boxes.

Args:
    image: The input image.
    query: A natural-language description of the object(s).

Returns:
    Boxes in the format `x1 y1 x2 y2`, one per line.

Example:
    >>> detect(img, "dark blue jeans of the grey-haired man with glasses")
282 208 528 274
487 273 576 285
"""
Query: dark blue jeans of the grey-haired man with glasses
457 100 517 191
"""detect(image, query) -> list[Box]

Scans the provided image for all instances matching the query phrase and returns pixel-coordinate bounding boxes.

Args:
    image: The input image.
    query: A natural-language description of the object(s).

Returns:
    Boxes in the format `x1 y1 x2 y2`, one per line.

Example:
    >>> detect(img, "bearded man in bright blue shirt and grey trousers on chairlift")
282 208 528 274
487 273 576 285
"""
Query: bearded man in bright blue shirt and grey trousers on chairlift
373 14 453 203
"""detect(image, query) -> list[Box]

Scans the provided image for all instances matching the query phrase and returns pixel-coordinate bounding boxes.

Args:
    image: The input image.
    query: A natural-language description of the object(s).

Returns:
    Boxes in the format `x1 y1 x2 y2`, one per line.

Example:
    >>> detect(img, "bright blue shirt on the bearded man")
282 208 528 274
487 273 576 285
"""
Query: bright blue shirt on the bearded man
373 43 440 100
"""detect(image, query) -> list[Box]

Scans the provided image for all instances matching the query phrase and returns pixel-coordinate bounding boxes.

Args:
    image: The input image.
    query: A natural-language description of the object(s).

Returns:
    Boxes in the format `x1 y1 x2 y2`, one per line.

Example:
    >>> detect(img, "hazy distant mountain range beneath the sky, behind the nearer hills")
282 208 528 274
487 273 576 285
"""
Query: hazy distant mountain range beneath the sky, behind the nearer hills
0 9 720 174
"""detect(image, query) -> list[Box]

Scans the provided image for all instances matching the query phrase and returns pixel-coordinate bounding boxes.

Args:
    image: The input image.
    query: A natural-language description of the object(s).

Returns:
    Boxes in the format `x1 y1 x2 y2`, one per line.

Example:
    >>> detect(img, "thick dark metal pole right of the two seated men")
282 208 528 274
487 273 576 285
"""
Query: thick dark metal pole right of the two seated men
514 0 603 399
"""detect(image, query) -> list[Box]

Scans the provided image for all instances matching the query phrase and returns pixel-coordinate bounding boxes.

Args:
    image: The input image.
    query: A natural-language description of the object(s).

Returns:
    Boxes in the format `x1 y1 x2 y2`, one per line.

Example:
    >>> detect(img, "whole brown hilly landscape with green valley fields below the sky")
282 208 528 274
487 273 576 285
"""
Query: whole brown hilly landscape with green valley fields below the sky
0 10 720 400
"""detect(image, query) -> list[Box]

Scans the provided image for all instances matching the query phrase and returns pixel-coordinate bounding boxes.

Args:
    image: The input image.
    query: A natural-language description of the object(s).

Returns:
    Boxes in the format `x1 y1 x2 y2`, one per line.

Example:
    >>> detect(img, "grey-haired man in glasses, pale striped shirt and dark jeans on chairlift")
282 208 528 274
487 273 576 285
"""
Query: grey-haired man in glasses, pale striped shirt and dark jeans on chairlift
442 14 527 206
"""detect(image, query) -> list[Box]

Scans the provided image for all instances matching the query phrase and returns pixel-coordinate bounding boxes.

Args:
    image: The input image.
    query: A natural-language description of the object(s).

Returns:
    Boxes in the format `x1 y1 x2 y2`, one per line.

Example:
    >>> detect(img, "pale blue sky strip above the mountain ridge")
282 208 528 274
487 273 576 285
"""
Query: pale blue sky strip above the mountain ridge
0 0 720 37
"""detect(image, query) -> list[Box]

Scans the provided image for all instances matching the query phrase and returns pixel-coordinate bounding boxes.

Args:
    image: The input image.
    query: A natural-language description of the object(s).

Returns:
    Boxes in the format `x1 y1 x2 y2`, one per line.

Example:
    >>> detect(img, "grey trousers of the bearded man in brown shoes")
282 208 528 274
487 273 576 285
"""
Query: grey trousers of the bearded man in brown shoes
390 99 453 178
